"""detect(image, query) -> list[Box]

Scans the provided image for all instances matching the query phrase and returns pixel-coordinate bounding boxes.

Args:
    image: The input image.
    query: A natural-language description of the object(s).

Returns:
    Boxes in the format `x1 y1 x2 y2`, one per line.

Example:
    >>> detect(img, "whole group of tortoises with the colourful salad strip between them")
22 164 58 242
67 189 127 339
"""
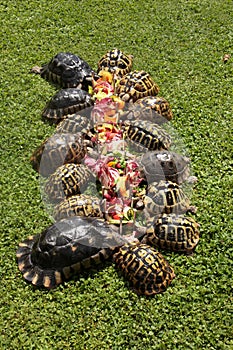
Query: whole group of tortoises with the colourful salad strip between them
17 49 199 295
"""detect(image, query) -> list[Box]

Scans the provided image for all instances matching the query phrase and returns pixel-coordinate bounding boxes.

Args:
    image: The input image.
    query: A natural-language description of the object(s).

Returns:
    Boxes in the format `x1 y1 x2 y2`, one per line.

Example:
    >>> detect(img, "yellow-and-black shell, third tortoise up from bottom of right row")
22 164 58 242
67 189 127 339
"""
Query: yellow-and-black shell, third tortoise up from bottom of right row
144 180 196 217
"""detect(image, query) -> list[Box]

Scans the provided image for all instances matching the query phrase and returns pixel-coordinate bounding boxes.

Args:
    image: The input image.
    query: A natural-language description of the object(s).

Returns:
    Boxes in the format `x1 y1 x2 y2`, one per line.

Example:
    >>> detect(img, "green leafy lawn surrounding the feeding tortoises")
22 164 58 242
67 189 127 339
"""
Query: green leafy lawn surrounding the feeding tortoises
0 0 233 350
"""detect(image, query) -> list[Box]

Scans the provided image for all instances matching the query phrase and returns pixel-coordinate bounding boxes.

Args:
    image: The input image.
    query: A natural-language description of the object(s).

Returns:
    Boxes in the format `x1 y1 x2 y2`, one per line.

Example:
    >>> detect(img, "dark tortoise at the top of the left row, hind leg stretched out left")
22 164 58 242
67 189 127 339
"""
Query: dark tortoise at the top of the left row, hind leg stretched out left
31 52 98 91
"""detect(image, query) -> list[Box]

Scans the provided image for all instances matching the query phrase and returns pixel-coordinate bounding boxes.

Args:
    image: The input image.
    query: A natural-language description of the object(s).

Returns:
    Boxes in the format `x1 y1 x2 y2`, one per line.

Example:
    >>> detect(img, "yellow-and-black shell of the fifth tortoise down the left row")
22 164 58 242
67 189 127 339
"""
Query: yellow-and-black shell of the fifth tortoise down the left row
44 163 92 202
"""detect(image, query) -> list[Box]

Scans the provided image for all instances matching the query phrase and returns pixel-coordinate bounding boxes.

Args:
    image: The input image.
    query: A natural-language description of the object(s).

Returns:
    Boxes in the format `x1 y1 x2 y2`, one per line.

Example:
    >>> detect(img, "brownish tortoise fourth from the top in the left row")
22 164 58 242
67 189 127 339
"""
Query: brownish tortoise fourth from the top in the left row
30 134 93 177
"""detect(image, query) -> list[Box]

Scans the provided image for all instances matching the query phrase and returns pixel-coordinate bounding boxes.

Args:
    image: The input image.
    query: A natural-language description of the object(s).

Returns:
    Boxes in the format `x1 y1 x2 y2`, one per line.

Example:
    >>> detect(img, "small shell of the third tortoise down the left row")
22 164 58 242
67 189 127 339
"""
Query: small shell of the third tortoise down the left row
56 113 93 134
